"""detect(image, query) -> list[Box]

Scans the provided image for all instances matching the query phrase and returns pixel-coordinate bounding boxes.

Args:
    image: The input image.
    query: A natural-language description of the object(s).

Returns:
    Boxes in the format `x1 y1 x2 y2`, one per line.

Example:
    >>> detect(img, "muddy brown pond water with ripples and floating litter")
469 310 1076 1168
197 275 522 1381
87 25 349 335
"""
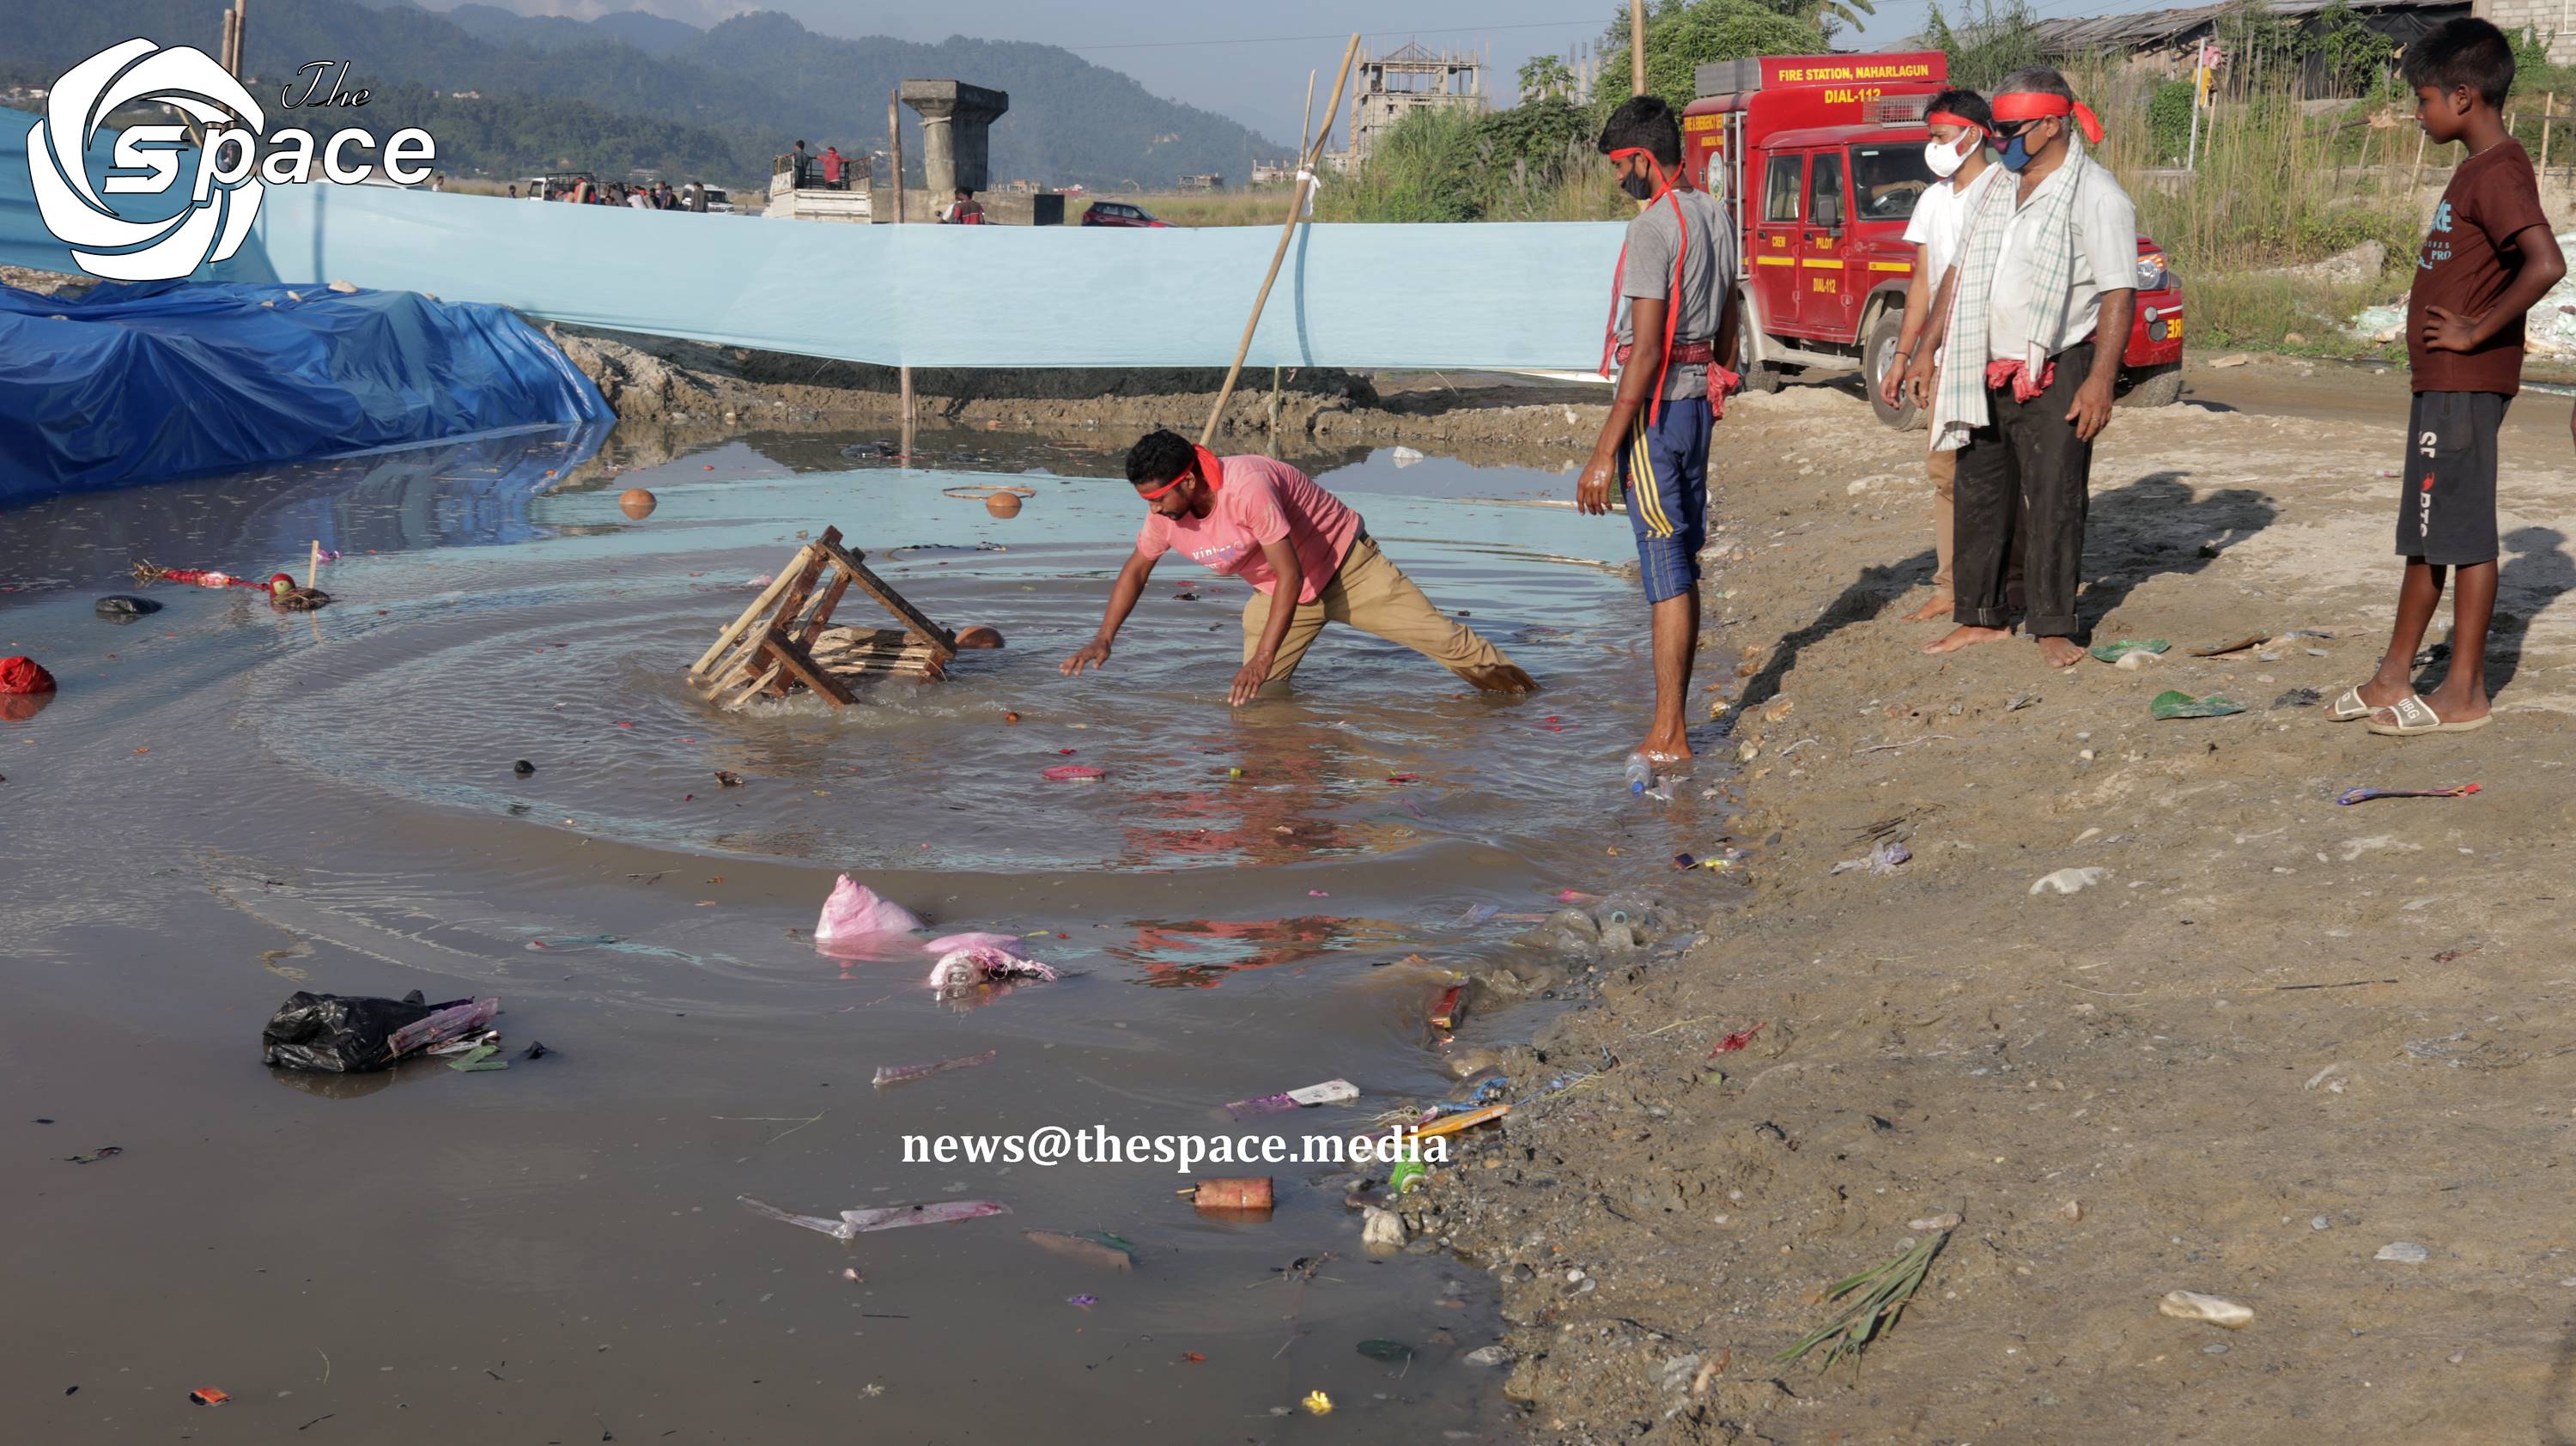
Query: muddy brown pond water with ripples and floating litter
0 422 1716 1443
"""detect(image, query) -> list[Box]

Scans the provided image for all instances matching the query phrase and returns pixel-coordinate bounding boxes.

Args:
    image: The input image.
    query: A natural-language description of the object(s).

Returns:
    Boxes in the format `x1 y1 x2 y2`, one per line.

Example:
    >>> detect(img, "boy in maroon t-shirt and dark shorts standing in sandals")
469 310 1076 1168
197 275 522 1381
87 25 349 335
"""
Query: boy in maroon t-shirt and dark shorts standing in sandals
2329 18 2566 738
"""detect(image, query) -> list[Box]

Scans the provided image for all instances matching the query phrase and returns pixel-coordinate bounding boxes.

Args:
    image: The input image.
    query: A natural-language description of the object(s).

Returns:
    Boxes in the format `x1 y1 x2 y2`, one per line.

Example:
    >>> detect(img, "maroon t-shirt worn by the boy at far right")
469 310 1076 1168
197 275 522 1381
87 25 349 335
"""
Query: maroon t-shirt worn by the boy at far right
2406 139 2550 397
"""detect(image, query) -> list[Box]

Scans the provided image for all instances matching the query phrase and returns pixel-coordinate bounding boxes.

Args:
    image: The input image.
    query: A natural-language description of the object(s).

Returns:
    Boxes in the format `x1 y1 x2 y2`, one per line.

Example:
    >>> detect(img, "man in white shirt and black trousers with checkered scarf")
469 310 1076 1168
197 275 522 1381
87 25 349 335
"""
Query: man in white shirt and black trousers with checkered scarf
1906 67 2138 667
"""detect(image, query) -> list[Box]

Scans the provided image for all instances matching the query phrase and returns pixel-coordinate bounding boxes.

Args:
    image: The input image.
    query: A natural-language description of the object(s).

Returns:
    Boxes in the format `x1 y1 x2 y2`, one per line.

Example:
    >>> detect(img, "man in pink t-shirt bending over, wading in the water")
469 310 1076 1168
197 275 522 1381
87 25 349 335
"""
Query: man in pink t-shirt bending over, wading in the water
1064 430 1538 706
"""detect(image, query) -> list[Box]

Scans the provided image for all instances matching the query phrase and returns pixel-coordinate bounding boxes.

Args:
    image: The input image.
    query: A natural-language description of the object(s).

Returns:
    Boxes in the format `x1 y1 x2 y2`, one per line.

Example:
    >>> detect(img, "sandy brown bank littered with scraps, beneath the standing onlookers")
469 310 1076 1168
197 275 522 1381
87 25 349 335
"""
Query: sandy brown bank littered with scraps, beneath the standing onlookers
1417 361 2576 1443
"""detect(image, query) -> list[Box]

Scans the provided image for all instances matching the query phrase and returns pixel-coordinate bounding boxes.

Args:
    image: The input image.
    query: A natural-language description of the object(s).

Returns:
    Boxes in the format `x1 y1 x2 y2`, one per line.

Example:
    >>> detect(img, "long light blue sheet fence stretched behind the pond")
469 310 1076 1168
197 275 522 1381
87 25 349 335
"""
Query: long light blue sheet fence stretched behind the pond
0 125 1620 368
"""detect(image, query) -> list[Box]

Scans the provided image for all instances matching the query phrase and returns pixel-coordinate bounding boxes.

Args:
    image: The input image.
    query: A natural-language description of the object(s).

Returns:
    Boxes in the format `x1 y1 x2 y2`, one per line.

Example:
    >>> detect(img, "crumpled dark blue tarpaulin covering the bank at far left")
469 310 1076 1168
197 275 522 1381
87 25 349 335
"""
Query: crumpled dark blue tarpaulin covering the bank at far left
0 281 611 505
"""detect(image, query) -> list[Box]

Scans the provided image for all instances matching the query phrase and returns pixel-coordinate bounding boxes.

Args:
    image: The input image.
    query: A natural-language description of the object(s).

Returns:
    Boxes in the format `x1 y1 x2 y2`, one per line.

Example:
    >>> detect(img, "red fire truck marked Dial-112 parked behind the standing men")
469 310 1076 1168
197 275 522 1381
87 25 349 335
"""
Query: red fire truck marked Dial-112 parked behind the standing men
1682 52 2182 428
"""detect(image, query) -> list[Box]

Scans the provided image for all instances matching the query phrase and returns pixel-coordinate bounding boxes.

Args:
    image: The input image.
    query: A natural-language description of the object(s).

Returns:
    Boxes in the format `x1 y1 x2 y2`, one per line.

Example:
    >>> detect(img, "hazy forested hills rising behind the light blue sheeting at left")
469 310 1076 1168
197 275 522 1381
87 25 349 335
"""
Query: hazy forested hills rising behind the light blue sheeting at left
0 0 1280 188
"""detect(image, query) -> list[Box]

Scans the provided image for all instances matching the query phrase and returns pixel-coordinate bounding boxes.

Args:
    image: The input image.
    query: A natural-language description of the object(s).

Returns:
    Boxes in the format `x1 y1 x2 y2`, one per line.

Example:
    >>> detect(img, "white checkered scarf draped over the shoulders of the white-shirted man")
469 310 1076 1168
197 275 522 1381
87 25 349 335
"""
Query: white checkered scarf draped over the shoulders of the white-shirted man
1932 134 2112 451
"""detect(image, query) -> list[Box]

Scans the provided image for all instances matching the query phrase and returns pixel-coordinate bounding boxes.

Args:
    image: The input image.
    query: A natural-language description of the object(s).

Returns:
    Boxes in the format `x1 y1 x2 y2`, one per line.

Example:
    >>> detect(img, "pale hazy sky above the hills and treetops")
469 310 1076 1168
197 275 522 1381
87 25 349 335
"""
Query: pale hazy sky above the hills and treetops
459 0 2151 142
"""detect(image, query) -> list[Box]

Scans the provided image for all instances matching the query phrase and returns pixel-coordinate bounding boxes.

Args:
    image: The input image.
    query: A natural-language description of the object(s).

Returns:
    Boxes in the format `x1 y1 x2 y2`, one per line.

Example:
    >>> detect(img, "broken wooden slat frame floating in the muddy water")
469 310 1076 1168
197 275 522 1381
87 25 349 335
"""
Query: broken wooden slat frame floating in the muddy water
688 528 958 708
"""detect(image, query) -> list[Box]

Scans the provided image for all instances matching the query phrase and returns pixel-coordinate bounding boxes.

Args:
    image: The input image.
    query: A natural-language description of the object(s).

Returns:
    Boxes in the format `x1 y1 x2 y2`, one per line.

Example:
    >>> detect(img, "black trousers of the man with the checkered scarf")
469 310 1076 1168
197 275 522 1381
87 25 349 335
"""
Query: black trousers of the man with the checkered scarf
1950 340 2092 636
